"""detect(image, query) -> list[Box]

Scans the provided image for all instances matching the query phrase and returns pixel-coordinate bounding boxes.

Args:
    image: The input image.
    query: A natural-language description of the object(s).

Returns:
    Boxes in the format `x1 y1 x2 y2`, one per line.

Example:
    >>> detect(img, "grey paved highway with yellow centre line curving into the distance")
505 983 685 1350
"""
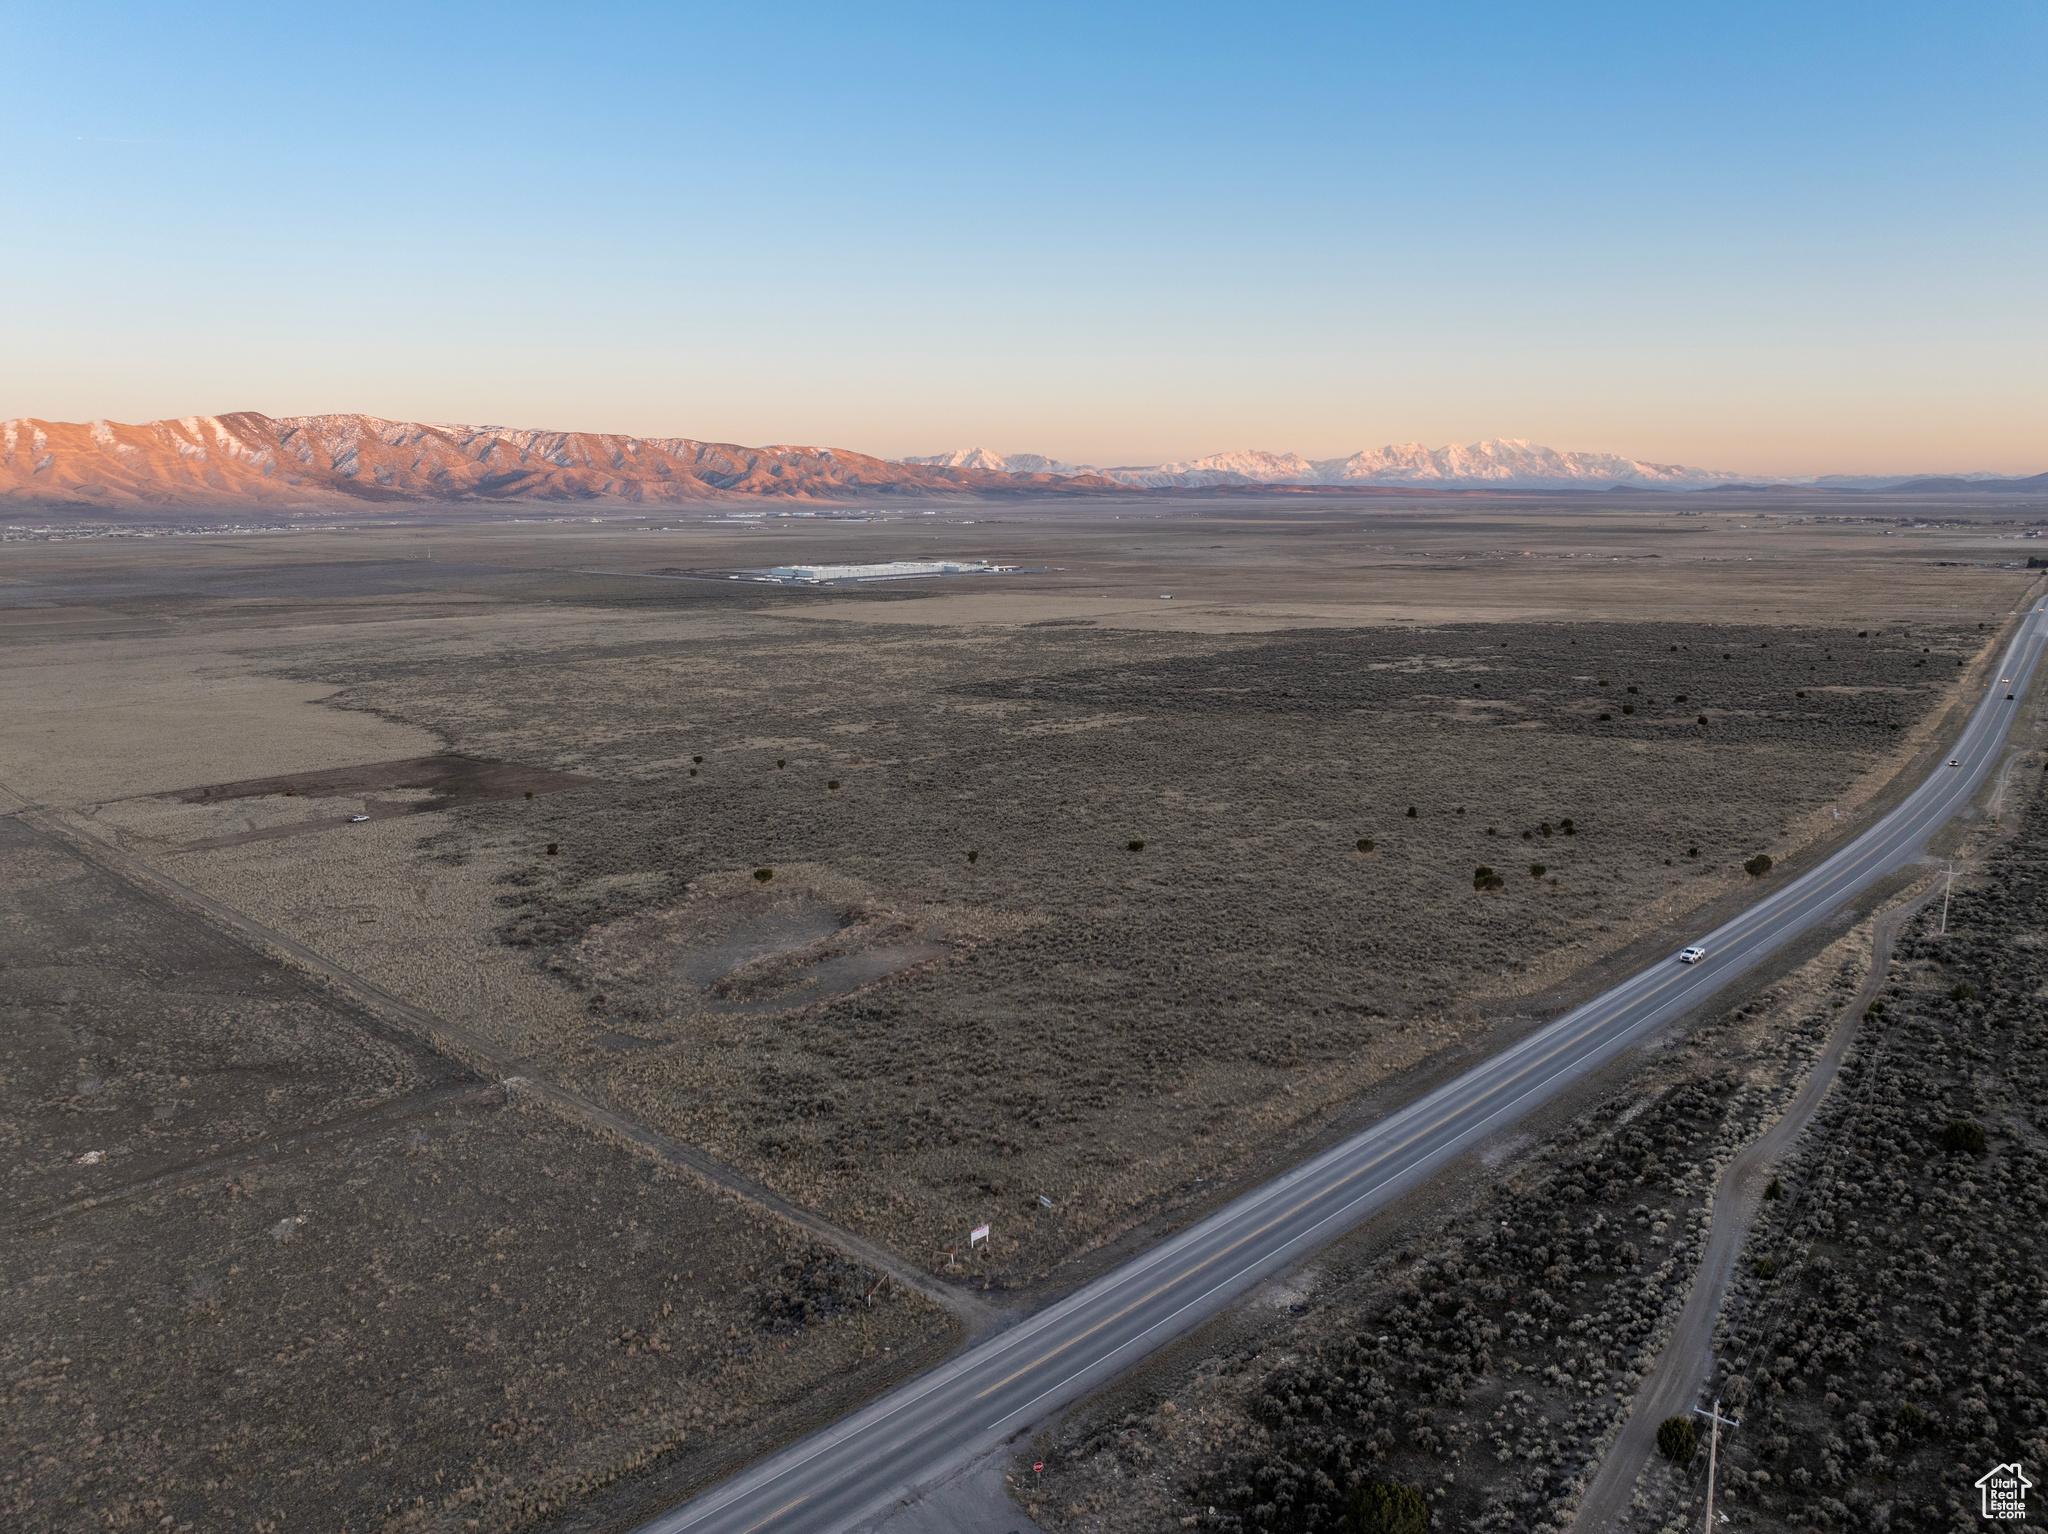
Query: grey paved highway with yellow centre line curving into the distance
641 608 2048 1534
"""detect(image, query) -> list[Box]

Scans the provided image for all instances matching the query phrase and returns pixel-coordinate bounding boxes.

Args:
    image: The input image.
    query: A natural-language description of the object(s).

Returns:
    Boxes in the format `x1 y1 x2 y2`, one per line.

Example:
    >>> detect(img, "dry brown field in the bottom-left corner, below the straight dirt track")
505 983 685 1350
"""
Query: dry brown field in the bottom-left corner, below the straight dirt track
0 819 950 1530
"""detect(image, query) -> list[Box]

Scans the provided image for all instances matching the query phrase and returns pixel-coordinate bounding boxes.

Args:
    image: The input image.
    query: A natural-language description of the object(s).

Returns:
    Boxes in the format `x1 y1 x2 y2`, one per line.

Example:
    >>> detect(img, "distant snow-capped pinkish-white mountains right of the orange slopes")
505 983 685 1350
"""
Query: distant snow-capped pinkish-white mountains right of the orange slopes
903 438 1747 489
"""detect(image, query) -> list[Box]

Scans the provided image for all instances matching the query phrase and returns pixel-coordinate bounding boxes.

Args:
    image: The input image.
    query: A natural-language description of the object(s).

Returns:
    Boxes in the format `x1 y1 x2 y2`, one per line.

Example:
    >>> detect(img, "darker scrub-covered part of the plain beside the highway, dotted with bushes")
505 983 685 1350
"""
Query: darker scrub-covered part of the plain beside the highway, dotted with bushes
207 623 1978 1282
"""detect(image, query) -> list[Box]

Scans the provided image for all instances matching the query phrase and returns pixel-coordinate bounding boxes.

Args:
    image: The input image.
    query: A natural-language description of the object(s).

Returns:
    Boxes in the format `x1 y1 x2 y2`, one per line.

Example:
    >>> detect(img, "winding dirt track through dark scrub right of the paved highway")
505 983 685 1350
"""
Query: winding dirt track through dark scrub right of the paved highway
1571 881 1942 1534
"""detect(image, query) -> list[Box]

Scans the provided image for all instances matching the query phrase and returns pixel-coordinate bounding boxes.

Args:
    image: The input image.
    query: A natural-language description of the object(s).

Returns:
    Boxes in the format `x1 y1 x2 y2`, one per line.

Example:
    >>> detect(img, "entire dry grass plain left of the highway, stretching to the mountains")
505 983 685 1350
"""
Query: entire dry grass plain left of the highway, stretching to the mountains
0 498 2030 1528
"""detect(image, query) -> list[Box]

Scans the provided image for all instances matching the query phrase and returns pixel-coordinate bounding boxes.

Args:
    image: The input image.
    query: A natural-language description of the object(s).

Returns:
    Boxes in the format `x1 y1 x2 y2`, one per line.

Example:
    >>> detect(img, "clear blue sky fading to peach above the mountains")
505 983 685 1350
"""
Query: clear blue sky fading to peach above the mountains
0 0 2048 473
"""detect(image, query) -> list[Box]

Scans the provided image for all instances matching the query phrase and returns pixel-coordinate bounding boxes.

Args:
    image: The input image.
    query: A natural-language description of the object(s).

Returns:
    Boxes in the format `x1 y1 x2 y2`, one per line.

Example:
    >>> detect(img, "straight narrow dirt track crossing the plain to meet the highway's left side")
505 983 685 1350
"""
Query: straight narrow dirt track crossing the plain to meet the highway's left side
0 786 993 1337
